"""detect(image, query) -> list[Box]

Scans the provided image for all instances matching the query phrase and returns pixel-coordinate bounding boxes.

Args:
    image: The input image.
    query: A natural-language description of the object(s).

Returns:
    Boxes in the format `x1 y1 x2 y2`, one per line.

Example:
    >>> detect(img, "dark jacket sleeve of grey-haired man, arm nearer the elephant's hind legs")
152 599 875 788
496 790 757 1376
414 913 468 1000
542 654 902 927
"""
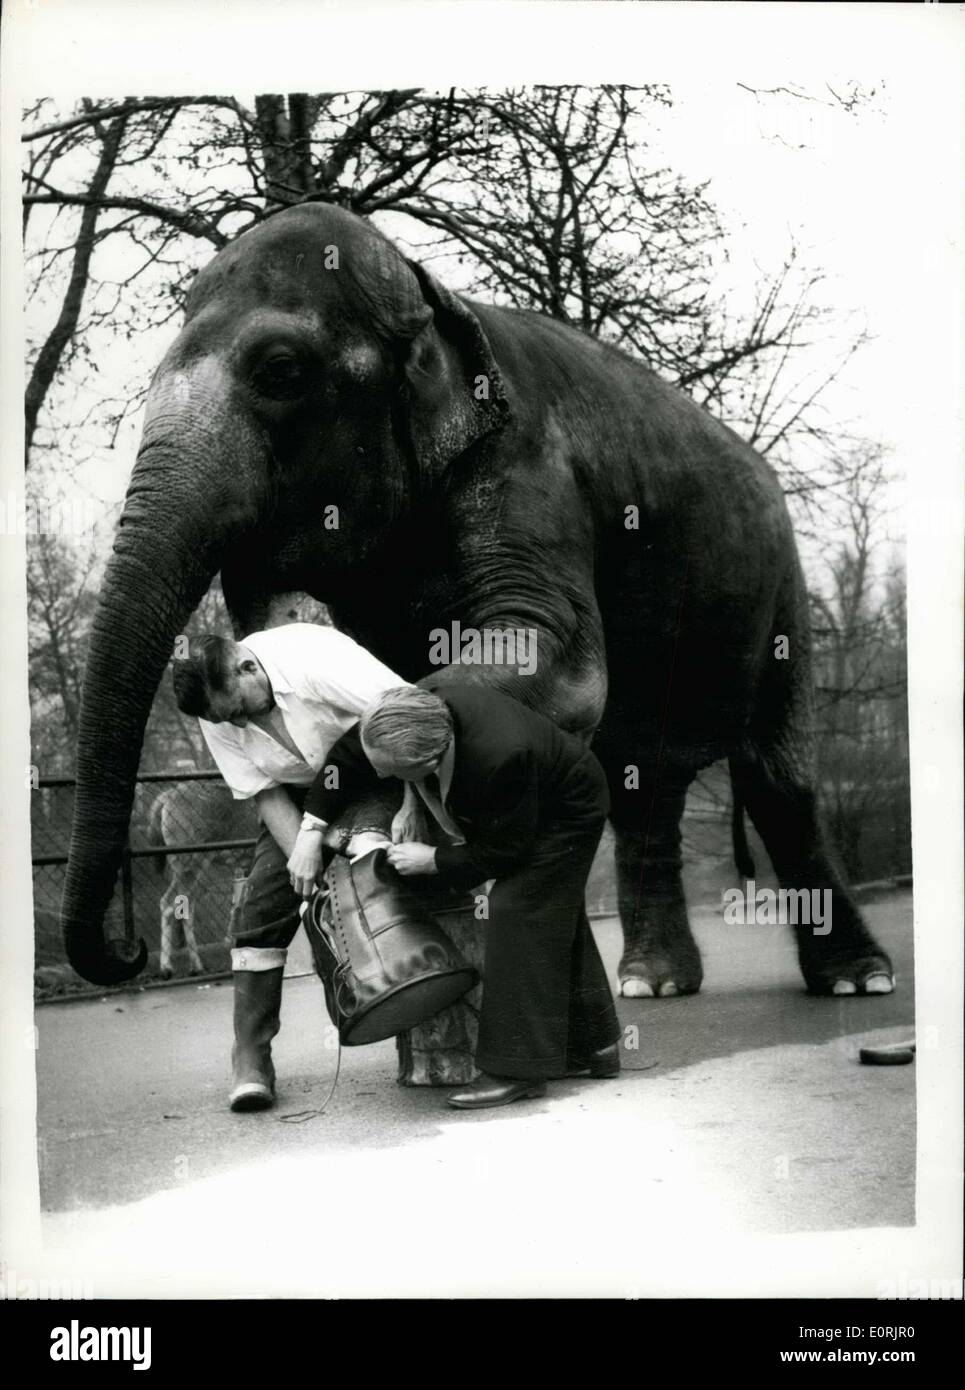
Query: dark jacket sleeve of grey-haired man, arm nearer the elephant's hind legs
435 749 538 888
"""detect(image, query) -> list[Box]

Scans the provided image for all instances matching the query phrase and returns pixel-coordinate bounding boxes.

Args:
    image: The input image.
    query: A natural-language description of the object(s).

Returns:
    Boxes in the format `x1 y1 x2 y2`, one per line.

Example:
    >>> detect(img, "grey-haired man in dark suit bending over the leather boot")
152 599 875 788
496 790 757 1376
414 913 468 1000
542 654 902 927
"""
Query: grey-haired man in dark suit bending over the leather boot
303 678 620 1109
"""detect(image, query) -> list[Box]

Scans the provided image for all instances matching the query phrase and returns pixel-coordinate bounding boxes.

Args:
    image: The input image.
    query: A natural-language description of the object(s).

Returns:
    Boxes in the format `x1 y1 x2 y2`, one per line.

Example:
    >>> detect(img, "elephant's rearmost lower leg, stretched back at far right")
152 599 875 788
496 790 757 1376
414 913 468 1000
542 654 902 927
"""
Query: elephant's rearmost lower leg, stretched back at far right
731 749 894 994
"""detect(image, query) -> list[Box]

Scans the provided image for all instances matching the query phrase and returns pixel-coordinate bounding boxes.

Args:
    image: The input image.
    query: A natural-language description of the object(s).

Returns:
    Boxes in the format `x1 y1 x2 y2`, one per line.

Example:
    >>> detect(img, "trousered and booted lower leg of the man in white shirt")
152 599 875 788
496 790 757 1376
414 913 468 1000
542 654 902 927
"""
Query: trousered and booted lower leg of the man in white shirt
229 806 300 1111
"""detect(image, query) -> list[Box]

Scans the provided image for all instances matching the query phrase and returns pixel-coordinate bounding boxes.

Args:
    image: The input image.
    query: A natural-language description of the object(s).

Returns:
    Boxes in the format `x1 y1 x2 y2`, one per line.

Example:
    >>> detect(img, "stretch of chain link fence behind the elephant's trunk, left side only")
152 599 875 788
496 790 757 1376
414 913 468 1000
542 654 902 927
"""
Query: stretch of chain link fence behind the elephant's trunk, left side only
31 769 257 998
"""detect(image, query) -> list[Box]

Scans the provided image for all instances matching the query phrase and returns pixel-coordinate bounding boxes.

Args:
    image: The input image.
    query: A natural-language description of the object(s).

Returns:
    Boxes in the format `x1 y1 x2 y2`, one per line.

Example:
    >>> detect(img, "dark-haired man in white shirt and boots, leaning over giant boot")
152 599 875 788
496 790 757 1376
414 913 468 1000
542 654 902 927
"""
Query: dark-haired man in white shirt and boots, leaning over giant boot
174 623 412 1111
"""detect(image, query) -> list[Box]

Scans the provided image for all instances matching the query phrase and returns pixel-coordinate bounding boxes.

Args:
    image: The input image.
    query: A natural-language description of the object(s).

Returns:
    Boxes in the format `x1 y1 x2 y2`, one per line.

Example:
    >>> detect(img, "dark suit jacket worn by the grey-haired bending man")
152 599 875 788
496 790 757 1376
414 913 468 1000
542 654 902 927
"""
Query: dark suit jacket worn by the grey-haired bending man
305 678 609 888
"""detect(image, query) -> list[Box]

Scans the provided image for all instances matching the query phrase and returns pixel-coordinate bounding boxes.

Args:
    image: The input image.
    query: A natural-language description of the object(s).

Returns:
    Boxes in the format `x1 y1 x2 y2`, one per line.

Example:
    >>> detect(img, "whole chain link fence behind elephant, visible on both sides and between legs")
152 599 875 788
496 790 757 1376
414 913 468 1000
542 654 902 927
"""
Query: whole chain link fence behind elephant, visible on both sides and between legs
31 765 911 998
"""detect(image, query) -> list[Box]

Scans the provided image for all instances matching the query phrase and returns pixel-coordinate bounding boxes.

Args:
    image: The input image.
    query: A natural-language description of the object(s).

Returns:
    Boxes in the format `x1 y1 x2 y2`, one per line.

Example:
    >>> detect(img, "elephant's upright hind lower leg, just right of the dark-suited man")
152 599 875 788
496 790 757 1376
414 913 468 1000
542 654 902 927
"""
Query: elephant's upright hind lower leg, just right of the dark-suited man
605 758 704 998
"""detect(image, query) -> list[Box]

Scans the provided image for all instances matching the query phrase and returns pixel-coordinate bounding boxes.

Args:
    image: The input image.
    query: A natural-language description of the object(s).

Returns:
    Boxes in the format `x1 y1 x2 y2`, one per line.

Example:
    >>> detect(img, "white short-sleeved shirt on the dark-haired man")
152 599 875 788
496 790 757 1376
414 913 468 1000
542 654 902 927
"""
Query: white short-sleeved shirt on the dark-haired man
197 623 410 801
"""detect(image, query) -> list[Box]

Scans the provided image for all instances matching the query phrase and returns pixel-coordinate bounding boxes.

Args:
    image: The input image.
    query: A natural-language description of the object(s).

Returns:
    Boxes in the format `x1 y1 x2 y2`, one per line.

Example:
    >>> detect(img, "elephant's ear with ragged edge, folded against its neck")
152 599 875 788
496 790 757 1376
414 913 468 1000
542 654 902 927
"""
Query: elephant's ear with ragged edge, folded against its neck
405 261 509 473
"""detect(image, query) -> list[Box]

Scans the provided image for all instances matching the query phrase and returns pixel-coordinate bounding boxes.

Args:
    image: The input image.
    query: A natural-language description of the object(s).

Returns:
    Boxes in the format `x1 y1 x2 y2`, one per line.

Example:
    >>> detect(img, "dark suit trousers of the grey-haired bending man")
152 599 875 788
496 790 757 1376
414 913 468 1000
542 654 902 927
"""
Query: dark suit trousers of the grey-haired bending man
476 755 620 1077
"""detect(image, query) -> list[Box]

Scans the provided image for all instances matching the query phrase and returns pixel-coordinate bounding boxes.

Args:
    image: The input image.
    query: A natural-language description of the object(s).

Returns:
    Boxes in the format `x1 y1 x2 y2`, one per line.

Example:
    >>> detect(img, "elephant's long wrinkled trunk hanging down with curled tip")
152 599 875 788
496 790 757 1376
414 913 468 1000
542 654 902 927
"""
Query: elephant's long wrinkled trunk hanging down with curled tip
61 400 266 984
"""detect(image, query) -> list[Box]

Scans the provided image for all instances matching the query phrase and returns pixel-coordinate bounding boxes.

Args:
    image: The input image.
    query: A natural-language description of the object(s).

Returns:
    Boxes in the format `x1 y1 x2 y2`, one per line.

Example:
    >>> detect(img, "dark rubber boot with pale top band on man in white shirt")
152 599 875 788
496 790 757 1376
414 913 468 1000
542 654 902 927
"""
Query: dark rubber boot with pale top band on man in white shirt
229 947 288 1111
